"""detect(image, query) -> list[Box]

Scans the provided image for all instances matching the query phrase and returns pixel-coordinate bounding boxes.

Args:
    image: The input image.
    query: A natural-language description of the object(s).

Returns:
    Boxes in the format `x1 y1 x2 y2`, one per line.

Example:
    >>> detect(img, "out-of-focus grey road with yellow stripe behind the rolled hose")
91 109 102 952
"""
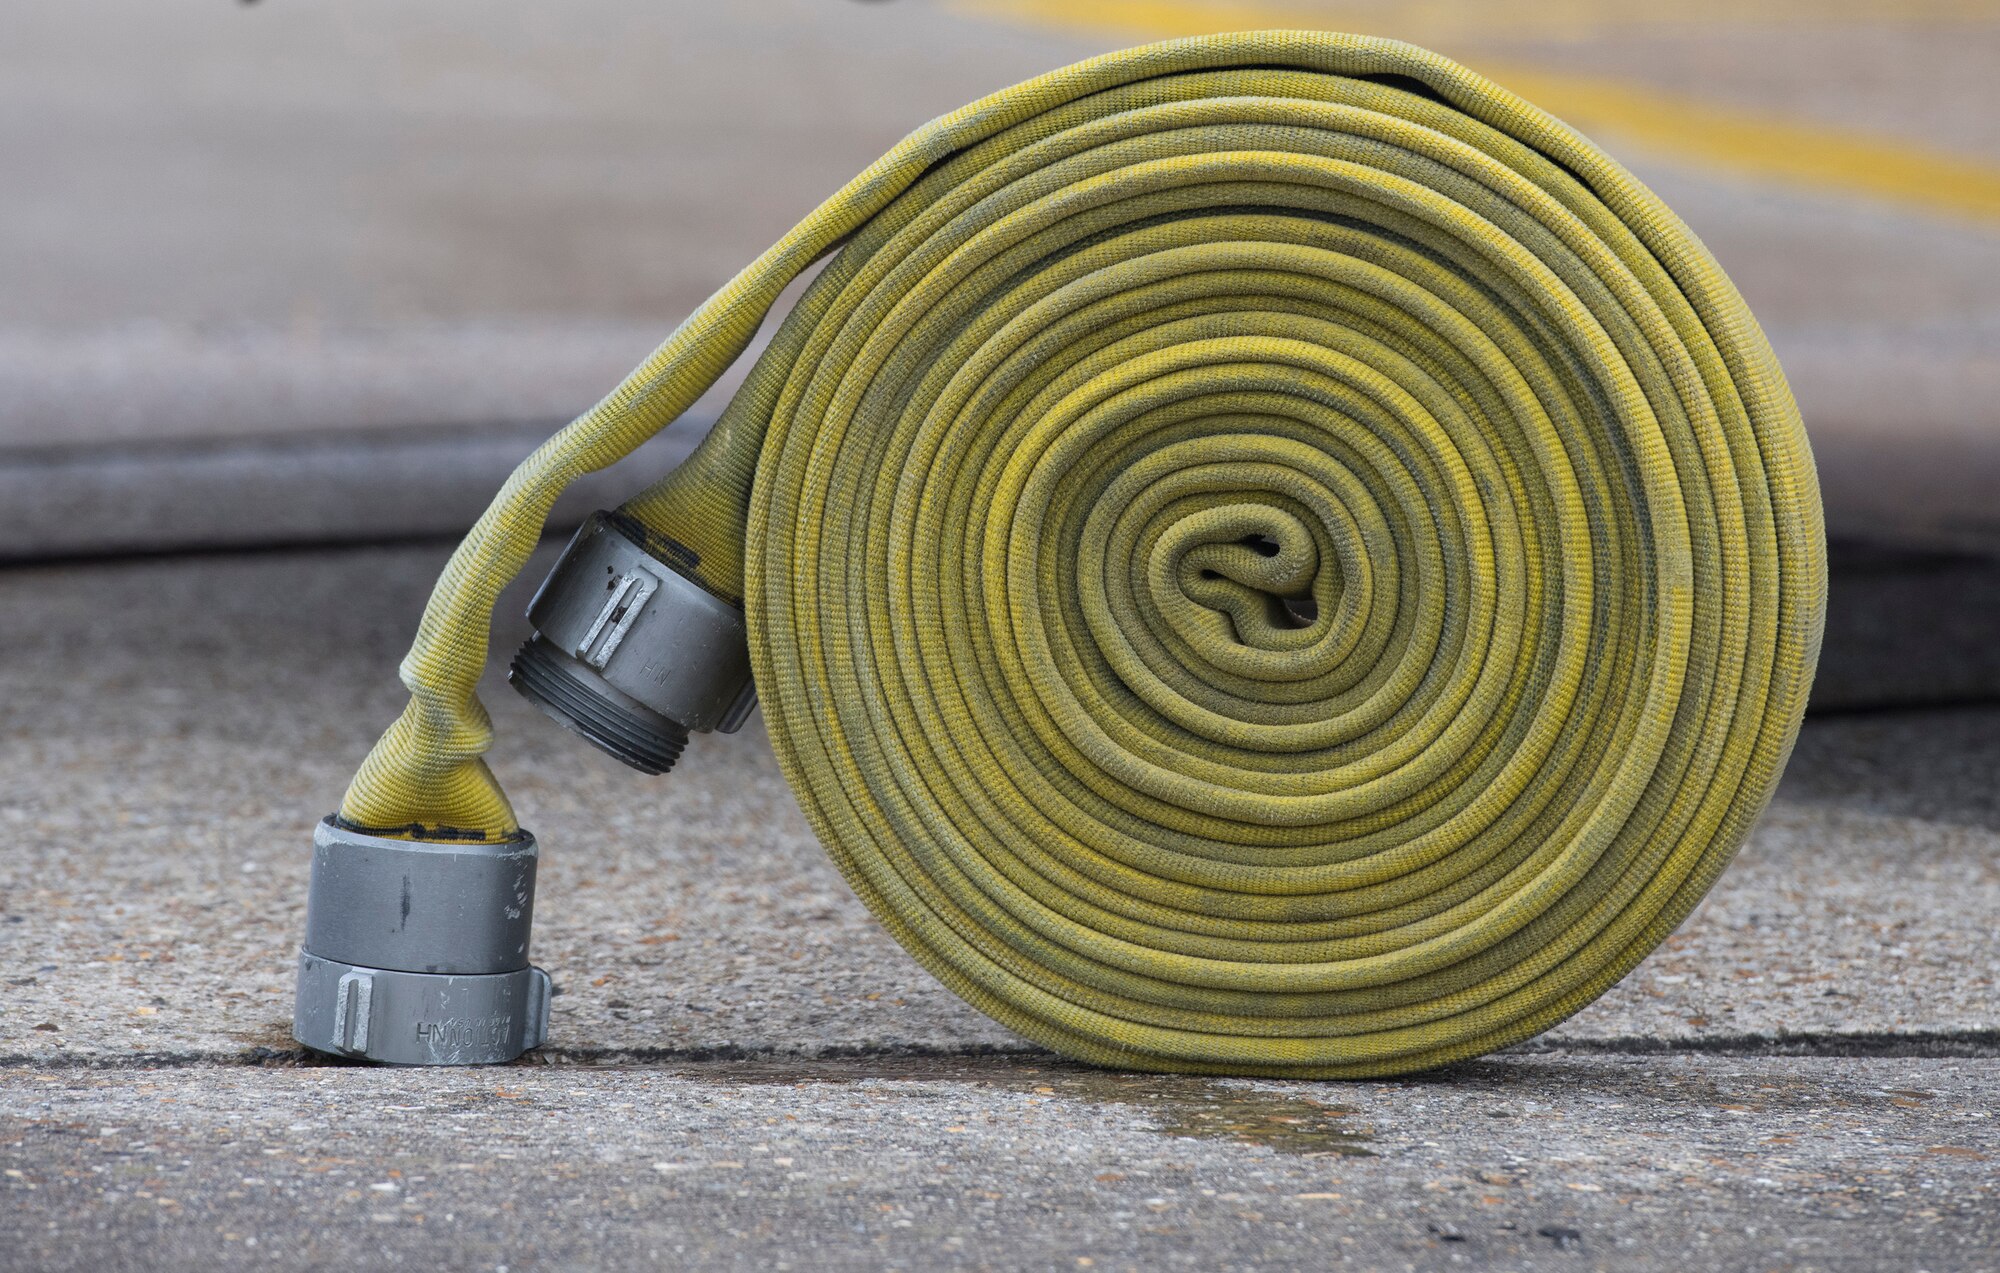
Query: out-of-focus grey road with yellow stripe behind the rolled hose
0 0 2000 558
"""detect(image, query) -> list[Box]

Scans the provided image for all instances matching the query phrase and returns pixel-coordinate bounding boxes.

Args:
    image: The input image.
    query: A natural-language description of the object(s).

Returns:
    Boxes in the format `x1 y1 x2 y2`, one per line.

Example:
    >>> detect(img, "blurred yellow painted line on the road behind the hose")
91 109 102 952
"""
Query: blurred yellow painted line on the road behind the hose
956 0 2000 224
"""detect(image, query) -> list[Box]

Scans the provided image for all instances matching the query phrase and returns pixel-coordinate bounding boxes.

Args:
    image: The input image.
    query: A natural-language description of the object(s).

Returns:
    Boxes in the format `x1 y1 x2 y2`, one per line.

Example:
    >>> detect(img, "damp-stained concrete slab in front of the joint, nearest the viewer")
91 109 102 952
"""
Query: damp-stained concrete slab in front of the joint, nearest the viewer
0 1057 2000 1273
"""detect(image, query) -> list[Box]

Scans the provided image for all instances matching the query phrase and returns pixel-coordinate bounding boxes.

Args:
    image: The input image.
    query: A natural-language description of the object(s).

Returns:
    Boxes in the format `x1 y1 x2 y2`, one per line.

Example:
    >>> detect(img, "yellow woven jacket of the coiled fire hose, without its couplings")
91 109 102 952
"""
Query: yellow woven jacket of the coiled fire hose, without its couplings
342 32 1826 1077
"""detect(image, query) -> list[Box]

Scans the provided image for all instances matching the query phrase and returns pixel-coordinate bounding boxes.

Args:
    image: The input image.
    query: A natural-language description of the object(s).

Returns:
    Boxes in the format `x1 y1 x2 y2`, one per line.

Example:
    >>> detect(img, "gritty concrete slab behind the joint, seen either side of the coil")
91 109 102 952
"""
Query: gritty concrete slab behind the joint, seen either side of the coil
0 546 2000 1065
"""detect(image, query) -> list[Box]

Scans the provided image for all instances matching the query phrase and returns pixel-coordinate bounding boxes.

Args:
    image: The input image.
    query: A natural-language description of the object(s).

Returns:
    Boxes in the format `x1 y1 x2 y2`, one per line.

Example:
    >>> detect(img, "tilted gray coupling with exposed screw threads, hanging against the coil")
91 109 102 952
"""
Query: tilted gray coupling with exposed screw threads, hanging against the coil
508 512 756 773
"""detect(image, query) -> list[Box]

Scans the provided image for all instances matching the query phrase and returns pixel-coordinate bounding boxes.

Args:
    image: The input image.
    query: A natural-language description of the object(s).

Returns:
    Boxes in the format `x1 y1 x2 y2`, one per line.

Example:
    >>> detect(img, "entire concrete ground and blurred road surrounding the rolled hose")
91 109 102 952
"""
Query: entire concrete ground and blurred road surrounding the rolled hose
0 0 2000 1273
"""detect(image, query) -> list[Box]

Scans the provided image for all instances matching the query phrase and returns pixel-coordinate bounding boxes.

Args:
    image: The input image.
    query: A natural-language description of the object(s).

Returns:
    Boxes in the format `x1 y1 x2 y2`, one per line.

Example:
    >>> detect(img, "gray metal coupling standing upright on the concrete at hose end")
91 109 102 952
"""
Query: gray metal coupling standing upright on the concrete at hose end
292 817 554 1065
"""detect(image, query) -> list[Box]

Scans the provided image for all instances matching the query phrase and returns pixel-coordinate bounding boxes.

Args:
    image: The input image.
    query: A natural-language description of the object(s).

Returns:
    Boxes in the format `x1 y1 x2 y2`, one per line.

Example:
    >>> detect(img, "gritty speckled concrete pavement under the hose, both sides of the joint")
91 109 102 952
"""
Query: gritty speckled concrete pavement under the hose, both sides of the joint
0 544 2000 1271
